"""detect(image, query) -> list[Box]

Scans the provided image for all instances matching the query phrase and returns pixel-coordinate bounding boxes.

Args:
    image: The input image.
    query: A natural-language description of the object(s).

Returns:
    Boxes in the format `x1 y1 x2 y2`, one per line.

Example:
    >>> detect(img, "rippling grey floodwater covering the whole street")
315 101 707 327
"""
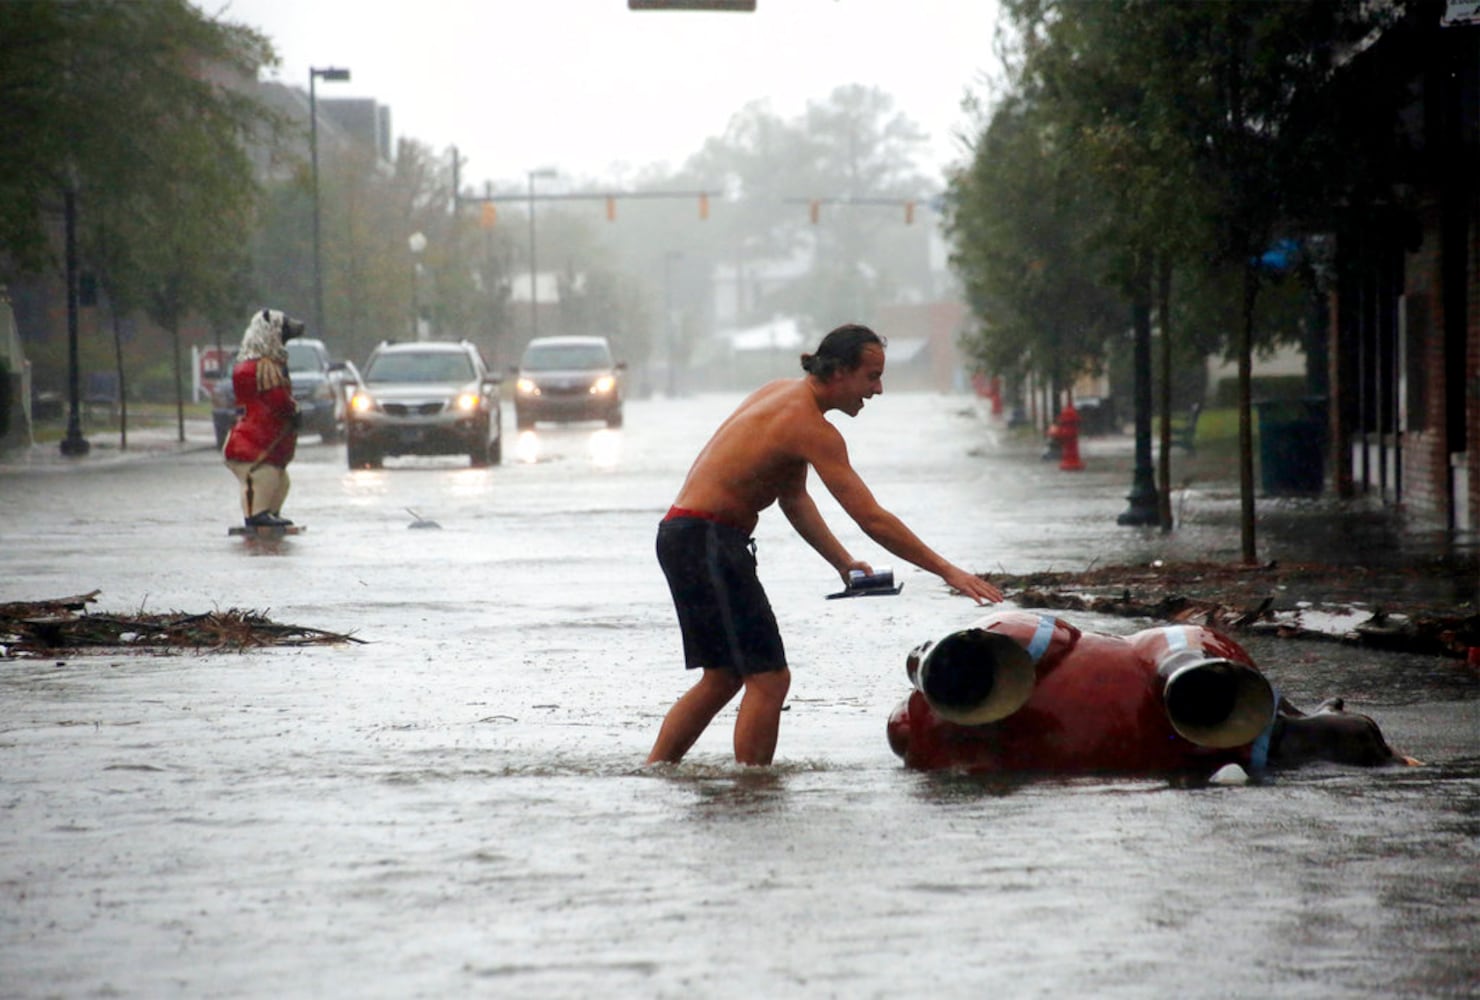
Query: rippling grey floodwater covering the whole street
0 395 1480 997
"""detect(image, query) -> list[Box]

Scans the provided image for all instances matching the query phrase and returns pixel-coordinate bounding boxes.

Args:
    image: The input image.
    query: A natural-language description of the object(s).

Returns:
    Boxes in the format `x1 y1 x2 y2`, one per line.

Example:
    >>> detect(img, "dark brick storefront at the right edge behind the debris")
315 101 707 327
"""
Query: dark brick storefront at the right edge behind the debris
1331 0 1480 533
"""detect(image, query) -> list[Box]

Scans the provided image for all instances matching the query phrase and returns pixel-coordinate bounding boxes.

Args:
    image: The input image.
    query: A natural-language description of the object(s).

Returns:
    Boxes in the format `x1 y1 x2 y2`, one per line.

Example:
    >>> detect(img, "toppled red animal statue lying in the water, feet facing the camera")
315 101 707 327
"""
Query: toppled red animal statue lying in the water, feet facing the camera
888 611 1412 774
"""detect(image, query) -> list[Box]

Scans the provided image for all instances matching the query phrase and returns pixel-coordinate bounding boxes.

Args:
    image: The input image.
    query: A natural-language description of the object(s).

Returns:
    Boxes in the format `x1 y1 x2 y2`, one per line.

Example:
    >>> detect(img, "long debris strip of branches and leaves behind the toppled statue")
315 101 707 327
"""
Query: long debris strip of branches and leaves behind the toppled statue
990 562 1480 658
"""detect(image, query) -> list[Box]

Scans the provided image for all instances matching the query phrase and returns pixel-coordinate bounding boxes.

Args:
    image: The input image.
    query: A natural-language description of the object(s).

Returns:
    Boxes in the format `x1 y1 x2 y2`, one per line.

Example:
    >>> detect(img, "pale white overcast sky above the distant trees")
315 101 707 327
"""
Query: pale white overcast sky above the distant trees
214 0 996 186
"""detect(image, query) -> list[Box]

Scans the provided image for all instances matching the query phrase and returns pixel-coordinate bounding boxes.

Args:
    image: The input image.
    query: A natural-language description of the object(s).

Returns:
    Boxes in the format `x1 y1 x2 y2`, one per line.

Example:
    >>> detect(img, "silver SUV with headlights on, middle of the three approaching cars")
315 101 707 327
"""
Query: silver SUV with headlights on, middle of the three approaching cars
345 340 503 469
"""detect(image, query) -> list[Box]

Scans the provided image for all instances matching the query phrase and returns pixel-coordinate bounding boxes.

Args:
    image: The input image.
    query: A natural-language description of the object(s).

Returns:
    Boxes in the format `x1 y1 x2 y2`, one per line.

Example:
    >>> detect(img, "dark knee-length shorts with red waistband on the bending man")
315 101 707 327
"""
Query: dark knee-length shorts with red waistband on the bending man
657 518 786 675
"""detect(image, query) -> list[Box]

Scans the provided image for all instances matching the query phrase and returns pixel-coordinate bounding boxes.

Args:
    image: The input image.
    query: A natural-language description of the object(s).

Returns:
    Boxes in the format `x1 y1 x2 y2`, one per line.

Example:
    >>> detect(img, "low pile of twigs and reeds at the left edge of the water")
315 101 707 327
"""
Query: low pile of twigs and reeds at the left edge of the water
0 590 361 658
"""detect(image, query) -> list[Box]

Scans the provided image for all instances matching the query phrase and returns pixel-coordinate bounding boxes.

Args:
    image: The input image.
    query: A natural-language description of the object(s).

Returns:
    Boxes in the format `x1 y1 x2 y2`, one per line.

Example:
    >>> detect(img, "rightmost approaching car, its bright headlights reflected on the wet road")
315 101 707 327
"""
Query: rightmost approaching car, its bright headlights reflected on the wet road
514 337 628 430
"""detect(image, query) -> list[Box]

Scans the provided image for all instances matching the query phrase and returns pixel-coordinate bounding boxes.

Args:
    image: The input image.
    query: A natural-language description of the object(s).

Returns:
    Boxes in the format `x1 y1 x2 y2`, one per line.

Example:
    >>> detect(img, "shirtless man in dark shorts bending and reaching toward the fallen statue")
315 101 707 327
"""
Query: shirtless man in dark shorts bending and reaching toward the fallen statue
648 325 1002 765
